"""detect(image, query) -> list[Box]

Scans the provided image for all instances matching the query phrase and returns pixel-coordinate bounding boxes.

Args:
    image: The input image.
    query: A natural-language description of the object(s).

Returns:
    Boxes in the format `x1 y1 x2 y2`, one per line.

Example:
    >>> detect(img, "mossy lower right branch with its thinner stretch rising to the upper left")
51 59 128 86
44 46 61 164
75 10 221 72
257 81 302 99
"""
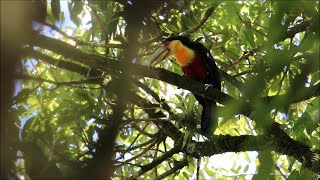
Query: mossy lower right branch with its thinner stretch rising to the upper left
130 93 319 172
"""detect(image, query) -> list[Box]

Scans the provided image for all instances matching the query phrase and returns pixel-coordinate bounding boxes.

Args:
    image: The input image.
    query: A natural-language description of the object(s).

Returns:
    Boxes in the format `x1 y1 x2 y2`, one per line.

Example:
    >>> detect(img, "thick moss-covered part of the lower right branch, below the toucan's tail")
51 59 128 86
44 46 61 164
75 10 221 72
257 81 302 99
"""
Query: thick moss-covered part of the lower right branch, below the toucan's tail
175 123 319 172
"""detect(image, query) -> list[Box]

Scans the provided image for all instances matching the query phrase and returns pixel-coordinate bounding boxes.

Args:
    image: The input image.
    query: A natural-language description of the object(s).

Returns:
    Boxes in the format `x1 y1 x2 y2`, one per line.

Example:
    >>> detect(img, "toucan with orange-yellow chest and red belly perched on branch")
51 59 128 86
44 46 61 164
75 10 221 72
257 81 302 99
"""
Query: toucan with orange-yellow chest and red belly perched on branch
149 36 221 136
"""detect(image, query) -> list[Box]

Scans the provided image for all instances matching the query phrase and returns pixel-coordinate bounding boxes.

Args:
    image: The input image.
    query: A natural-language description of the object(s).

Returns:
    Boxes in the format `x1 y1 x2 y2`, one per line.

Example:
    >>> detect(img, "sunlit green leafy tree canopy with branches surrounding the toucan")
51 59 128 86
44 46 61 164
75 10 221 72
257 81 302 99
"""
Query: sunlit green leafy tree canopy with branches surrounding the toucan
1 0 320 179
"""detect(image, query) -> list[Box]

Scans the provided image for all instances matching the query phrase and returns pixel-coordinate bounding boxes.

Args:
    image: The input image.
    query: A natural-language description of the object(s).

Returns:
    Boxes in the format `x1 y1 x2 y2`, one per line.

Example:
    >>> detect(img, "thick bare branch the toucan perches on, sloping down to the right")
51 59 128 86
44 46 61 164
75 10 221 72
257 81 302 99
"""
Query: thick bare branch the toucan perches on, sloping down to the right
25 35 314 114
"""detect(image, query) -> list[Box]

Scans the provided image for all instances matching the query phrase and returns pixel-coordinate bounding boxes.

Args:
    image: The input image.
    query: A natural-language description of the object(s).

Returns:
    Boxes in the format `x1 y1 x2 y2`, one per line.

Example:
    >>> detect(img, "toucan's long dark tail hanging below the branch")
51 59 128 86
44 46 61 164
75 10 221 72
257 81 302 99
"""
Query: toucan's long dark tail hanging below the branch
201 102 218 136
